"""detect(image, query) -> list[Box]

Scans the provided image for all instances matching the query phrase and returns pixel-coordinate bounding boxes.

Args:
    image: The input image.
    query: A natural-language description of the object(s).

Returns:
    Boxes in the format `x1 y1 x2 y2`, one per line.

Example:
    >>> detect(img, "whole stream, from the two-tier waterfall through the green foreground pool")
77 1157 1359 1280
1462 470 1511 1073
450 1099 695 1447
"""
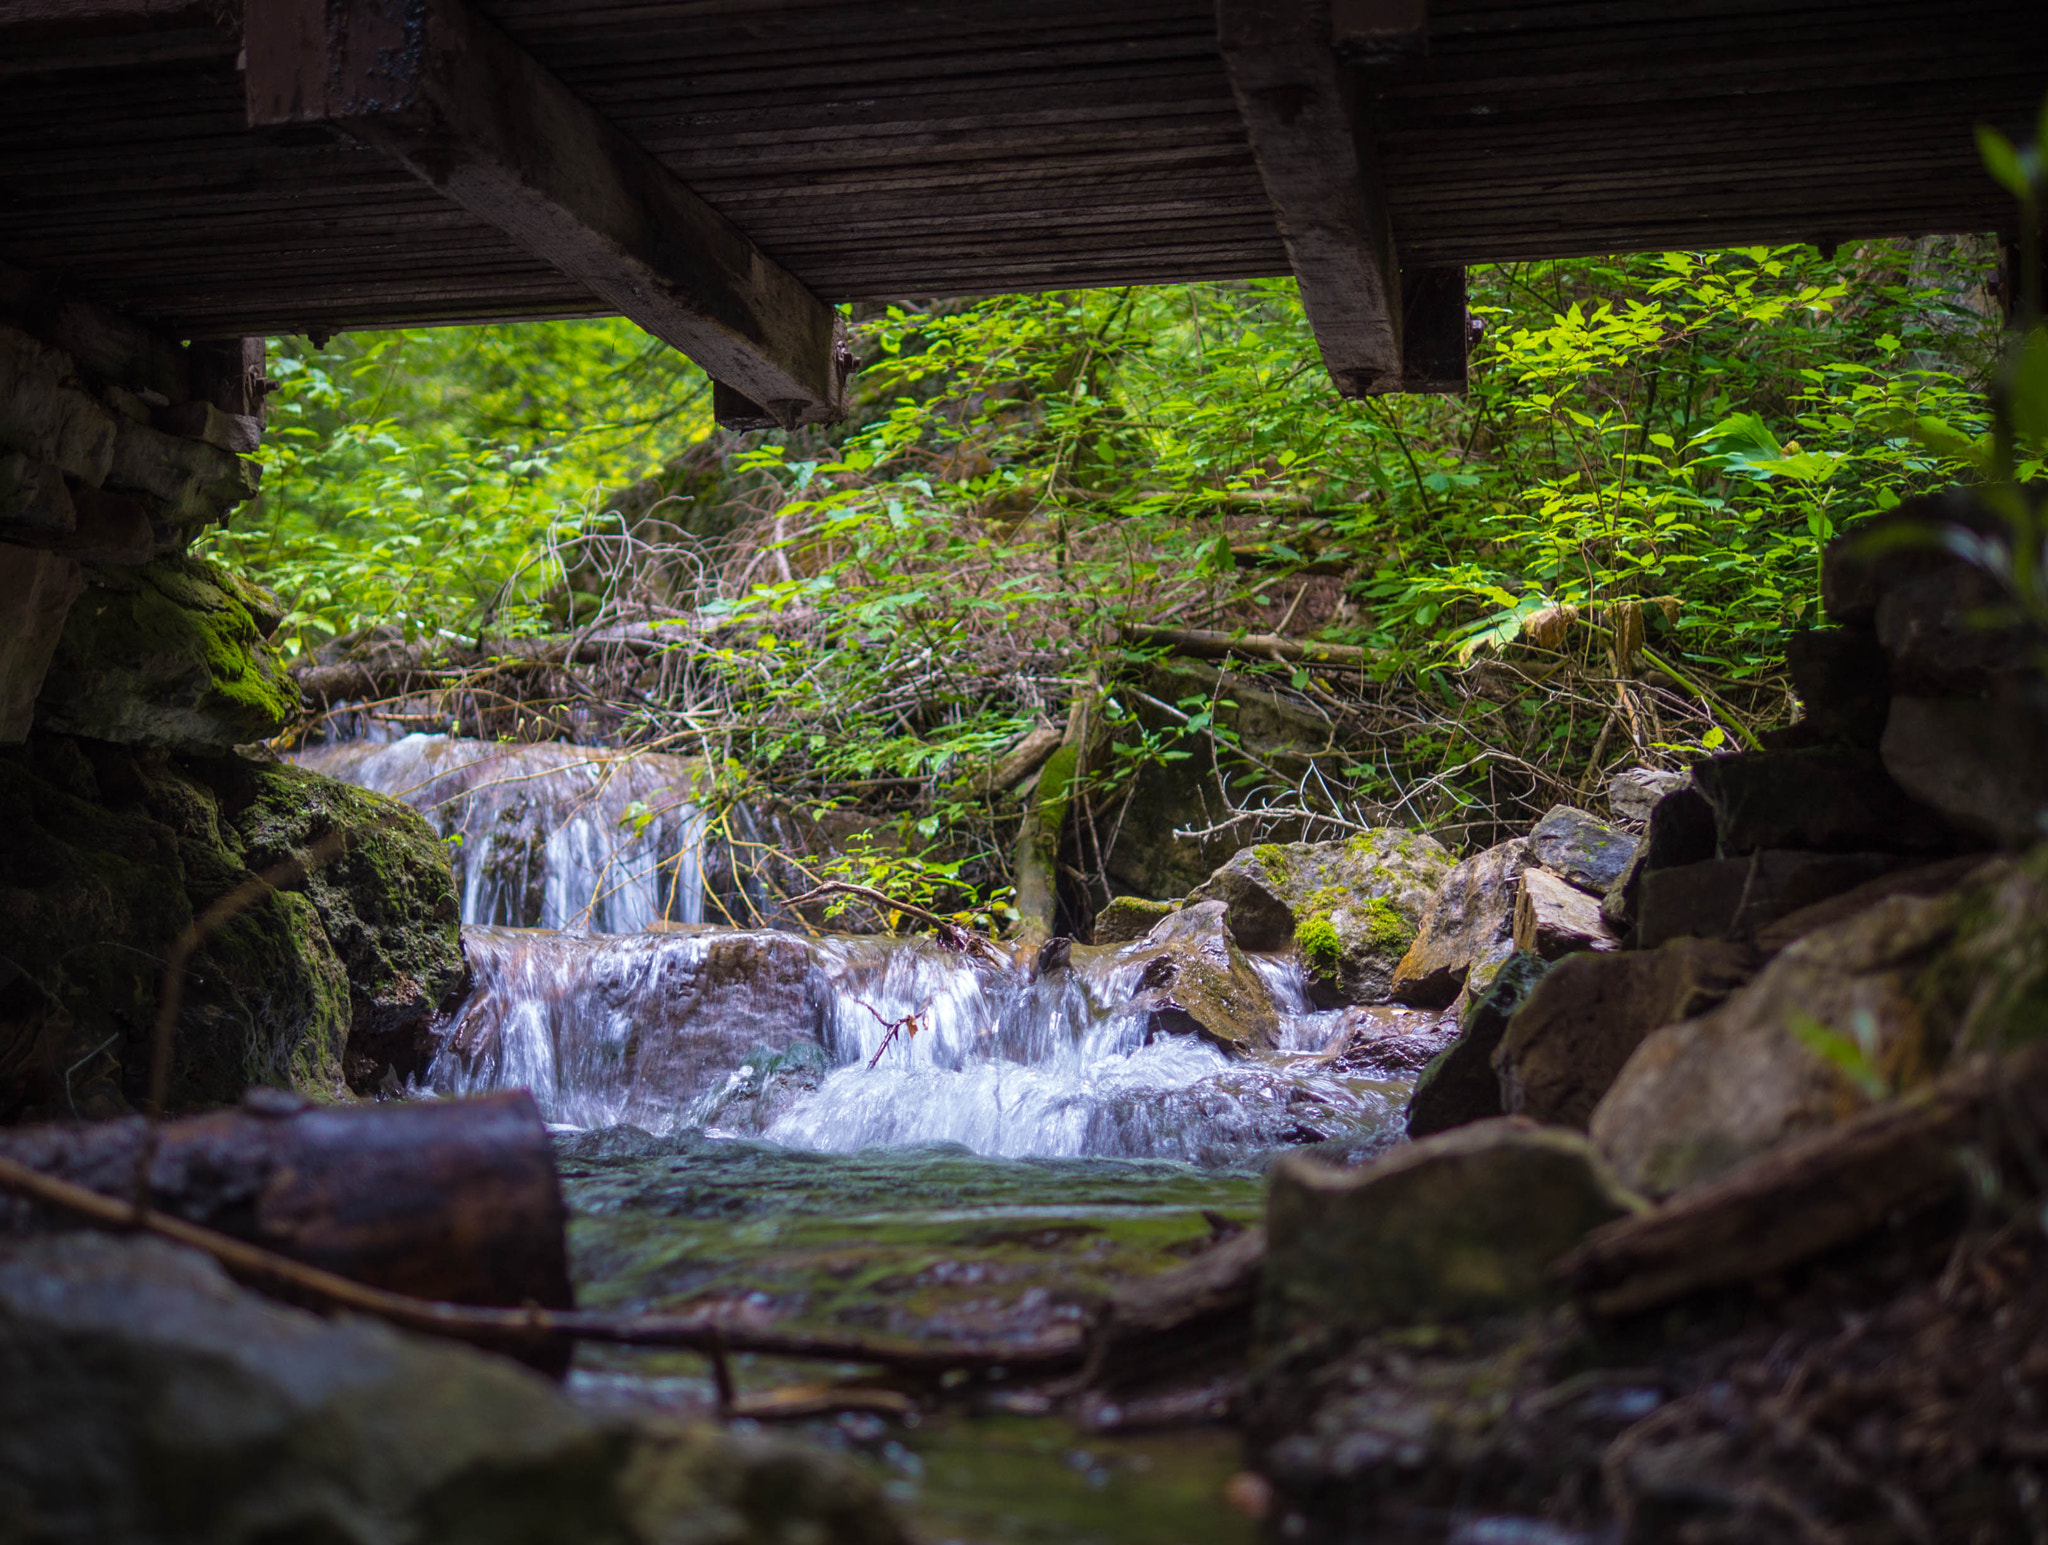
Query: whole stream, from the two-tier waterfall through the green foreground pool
299 736 1427 1545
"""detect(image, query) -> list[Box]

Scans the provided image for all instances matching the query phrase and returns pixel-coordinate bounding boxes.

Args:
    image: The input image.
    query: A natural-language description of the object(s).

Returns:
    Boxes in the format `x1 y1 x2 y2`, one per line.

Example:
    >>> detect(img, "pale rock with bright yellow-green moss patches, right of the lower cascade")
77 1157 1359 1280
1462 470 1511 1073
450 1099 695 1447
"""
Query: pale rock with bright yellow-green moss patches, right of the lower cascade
1188 826 1450 1002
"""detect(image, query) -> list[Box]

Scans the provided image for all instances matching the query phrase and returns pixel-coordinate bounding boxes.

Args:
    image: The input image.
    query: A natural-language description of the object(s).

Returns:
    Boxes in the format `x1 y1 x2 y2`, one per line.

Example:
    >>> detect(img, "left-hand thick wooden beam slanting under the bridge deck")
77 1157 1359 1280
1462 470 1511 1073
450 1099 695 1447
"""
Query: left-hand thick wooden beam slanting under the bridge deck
244 0 852 426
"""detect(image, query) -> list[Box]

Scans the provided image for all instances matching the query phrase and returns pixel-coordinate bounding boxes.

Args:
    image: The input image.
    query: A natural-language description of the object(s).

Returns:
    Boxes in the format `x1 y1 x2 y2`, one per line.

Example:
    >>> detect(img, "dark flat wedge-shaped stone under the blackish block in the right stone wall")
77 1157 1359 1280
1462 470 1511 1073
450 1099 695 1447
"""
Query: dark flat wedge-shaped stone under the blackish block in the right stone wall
1634 850 1913 949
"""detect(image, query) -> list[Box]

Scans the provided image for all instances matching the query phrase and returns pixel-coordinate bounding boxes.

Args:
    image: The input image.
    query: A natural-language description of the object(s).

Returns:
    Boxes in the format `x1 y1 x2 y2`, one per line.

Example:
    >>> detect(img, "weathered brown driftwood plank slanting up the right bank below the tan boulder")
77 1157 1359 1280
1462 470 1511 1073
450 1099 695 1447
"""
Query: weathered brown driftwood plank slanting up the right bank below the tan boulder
1556 1043 2048 1316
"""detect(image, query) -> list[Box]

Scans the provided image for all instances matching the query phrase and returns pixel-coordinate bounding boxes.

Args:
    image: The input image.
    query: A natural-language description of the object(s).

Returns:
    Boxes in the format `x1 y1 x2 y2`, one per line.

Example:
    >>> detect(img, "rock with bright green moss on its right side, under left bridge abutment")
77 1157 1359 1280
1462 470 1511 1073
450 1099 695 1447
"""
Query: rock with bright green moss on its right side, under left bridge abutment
35 553 299 754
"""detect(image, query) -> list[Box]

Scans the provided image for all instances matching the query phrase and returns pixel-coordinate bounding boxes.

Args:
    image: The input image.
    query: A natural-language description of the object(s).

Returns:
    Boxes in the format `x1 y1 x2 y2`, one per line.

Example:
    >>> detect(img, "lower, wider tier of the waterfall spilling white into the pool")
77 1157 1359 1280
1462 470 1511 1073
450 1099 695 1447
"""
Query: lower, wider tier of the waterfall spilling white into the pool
428 928 1405 1164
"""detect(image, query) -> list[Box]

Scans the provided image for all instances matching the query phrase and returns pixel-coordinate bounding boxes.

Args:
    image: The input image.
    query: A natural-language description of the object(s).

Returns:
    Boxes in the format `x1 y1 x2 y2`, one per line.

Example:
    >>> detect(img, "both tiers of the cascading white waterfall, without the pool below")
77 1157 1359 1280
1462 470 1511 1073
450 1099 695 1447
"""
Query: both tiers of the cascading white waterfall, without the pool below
303 736 1441 1164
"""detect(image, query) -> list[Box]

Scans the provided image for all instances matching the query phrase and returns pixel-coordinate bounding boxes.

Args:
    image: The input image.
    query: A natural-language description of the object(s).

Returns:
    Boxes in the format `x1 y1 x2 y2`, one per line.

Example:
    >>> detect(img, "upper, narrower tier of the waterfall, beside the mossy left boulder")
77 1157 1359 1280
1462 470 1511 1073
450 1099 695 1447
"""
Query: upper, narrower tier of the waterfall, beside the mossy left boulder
293 736 705 934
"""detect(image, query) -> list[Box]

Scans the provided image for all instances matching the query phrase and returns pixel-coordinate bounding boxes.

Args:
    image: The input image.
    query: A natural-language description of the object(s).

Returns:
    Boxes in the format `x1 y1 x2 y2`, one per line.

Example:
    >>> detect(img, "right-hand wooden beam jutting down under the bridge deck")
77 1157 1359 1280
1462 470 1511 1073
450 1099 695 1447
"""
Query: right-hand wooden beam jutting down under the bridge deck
1217 0 1403 398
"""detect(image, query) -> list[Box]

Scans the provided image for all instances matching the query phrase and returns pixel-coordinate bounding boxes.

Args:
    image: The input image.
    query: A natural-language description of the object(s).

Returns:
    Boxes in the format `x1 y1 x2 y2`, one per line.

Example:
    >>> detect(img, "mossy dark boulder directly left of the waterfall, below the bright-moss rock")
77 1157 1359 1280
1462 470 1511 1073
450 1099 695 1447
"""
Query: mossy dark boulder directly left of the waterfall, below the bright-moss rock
229 762 467 1092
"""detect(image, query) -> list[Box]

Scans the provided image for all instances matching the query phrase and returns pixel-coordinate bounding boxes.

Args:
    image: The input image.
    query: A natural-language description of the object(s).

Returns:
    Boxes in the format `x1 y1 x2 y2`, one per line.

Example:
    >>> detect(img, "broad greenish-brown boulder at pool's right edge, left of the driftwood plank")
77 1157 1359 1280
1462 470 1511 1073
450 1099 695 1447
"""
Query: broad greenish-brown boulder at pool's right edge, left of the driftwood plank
1257 1117 1642 1346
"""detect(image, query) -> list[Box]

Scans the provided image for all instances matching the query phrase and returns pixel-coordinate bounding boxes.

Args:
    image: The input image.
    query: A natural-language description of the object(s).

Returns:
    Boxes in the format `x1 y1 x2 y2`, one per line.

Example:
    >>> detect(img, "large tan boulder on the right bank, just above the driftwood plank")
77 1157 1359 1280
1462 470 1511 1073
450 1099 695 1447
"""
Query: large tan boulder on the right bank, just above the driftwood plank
1591 895 1958 1197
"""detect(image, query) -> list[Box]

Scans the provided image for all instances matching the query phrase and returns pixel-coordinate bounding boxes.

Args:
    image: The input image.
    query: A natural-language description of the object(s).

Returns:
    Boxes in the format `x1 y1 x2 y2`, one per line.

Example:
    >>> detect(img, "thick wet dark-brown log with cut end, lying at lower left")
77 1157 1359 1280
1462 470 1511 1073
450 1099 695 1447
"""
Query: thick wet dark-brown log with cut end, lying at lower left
0 1090 575 1360
